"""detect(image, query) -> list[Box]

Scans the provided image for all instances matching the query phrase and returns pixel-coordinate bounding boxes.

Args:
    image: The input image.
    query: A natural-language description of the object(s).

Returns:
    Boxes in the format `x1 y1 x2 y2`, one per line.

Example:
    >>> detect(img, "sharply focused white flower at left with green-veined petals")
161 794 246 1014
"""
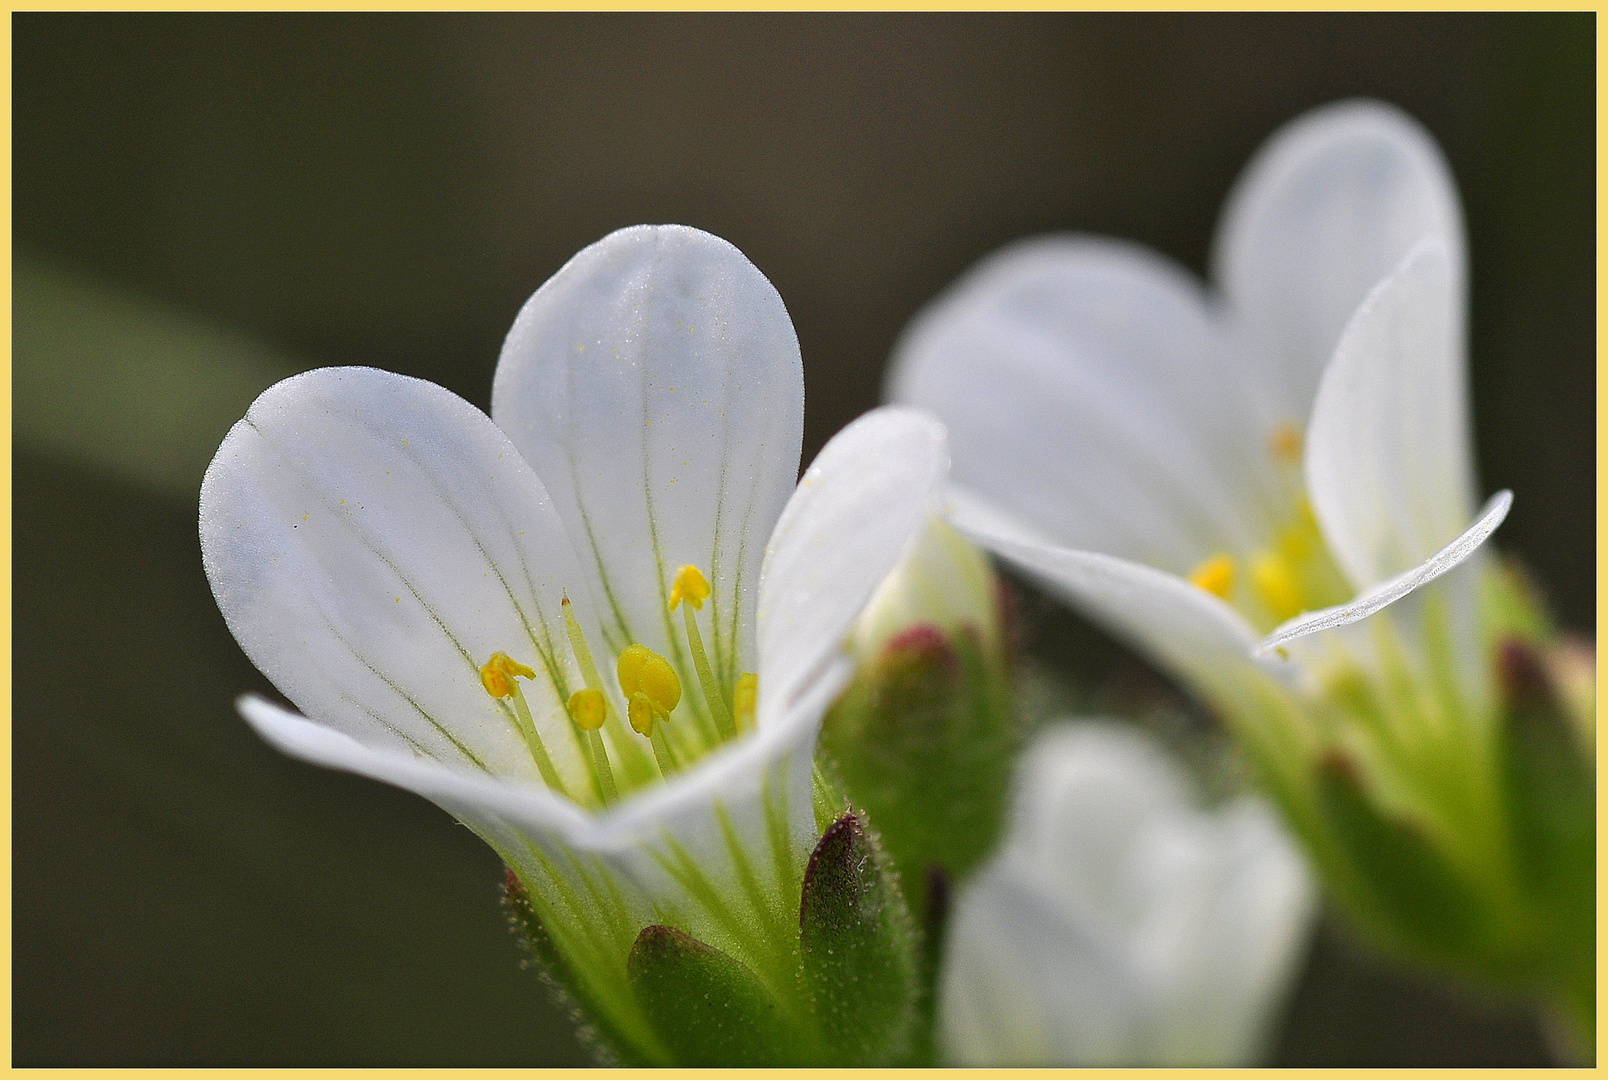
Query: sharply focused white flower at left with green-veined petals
201 227 946 1061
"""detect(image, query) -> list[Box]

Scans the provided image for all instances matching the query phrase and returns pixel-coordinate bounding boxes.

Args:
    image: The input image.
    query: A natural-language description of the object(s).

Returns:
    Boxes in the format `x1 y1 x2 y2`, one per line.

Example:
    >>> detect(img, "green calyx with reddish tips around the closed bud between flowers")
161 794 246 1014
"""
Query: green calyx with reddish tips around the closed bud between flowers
820 624 1021 911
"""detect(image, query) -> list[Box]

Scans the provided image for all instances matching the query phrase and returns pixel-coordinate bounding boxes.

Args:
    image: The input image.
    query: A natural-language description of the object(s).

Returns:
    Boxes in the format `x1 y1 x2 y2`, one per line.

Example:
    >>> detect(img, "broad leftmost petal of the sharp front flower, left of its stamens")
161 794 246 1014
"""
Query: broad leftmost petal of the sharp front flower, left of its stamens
201 368 584 793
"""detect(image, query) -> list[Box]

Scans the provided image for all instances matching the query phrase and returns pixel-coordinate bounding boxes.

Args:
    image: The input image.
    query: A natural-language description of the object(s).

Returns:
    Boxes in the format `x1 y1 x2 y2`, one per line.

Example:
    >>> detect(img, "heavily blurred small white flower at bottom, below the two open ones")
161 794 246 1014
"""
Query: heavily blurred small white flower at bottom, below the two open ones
939 722 1314 1066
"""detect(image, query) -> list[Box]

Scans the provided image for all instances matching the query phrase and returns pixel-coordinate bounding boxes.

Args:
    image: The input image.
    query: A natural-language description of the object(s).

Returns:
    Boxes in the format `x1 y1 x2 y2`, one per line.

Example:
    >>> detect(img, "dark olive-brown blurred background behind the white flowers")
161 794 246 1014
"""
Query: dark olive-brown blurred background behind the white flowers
11 13 1595 1066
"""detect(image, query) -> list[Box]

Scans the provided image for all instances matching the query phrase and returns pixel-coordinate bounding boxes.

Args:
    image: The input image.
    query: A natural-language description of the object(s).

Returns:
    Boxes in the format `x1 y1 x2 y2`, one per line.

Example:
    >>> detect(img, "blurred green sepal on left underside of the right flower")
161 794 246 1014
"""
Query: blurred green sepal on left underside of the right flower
1317 754 1483 971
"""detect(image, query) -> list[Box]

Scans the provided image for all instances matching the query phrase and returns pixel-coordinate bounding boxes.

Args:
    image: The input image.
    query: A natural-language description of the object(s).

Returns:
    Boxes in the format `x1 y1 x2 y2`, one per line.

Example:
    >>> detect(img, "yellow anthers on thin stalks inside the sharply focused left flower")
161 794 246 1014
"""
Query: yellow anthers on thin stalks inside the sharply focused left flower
481 566 759 804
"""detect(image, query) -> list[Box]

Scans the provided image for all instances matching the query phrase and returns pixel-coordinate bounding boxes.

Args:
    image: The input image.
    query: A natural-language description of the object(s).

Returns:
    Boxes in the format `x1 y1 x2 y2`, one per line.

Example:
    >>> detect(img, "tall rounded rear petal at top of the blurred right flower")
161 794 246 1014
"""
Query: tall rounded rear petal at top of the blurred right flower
1214 101 1465 431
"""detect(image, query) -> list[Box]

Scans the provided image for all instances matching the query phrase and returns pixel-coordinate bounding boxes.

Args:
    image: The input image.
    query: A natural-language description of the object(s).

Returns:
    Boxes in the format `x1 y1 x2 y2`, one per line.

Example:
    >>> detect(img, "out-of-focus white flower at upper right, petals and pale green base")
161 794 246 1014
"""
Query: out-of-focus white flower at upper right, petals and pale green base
891 103 1512 842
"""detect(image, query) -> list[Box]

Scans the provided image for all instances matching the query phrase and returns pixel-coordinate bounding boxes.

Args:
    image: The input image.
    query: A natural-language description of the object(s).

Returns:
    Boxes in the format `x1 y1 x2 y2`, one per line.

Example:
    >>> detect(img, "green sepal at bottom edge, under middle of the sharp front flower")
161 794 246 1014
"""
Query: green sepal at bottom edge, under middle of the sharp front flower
626 926 809 1067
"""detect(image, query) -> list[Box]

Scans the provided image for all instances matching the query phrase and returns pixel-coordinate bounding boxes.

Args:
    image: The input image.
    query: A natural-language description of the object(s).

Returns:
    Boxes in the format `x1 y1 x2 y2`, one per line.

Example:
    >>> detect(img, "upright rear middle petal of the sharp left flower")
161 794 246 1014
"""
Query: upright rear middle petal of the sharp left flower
492 225 804 683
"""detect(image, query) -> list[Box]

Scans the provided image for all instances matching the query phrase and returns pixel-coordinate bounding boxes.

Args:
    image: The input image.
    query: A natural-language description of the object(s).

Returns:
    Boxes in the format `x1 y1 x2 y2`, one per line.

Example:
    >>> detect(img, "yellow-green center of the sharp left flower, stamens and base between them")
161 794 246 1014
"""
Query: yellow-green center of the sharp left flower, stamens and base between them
481 566 759 805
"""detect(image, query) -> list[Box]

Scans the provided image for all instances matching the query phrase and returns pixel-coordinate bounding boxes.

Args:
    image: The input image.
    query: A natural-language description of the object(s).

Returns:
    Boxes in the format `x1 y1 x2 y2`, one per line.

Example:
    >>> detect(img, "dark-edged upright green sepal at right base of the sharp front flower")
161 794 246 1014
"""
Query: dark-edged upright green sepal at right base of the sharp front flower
799 812 920 1066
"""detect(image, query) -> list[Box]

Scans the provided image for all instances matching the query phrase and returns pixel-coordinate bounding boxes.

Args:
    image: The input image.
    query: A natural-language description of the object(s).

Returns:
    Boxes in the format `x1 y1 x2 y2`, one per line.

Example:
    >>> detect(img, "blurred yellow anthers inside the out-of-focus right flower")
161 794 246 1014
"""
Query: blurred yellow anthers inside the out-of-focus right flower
1190 424 1351 632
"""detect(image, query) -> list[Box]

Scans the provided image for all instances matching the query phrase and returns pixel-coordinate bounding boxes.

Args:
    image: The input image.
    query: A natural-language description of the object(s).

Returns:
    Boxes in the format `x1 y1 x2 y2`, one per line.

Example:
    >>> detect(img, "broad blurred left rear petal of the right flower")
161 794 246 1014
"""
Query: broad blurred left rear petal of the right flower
889 236 1274 572
